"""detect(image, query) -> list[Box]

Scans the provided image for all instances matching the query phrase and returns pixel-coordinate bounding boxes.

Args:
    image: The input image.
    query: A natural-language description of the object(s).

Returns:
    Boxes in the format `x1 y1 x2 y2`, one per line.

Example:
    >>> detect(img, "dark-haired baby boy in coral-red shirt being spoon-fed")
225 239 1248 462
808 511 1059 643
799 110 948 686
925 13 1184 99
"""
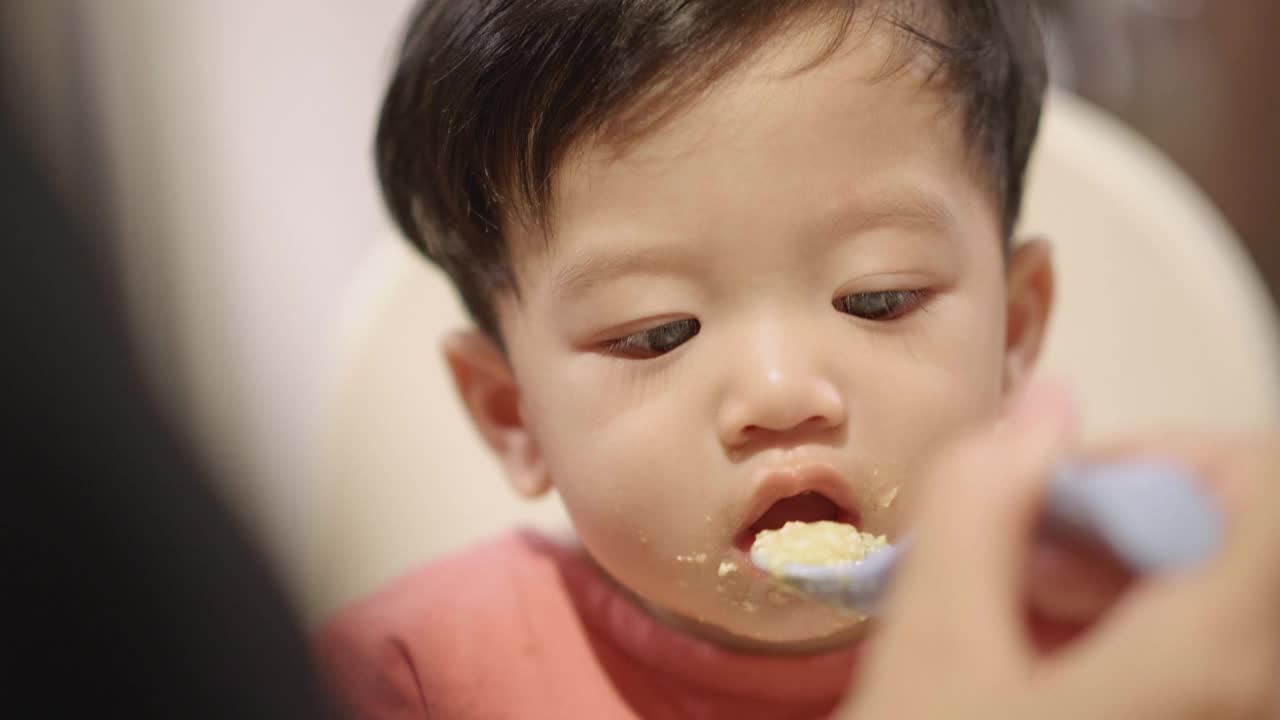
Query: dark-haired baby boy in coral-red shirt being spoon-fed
320 0 1052 719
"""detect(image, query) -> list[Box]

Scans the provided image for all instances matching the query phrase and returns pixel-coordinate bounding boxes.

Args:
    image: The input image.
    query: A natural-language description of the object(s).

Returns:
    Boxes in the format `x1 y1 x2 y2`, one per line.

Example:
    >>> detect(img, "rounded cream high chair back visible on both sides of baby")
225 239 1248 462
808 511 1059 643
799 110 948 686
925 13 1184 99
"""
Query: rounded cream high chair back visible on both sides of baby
305 91 1280 619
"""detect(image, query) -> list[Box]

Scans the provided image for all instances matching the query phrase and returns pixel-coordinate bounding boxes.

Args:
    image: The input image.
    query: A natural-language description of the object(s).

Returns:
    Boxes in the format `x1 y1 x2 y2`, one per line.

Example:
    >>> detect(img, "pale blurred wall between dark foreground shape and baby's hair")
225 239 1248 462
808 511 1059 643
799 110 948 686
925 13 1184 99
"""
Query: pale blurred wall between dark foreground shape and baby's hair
46 0 410 589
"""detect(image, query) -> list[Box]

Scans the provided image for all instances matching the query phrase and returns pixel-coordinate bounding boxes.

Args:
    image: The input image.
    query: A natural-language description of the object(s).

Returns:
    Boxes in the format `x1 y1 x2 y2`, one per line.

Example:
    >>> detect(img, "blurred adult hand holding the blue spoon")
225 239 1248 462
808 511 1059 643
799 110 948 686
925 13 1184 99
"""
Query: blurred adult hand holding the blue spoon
837 388 1280 720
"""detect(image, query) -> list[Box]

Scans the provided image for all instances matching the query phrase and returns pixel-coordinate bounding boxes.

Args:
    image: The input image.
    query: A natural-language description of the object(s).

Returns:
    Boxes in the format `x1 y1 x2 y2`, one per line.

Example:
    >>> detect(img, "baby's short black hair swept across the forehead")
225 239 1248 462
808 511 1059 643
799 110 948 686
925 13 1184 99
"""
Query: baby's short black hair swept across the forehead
376 0 1046 337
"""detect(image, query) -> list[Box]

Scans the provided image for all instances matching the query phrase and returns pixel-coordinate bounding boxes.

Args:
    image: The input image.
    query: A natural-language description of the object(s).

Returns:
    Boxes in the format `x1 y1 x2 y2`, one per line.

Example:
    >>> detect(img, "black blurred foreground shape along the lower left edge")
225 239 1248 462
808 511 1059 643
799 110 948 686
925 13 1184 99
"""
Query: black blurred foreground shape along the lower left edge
0 109 333 720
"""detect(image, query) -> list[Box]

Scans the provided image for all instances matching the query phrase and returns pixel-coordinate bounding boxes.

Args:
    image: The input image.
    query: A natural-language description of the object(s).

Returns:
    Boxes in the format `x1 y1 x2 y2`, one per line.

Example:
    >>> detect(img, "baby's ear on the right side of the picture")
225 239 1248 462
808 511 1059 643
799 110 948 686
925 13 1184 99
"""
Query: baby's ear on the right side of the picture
1004 240 1053 393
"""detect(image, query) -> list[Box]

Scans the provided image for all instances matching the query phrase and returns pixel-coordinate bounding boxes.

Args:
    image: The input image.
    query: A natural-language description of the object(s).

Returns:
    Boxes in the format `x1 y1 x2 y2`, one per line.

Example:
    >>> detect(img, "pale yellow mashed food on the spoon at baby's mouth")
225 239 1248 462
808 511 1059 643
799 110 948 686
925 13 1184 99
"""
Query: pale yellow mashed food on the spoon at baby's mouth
751 520 888 577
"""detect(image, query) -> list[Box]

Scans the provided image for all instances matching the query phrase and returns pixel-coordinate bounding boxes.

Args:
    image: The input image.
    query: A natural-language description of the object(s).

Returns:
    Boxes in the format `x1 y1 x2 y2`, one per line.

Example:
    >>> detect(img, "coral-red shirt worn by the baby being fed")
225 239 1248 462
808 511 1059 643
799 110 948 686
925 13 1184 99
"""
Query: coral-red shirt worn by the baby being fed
317 532 856 720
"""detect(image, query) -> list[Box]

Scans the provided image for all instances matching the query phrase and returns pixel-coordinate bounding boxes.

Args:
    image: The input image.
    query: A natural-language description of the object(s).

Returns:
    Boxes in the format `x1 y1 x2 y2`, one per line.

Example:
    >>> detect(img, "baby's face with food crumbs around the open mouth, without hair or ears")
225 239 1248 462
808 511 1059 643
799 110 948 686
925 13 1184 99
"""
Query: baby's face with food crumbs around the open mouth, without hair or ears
488 28 1037 650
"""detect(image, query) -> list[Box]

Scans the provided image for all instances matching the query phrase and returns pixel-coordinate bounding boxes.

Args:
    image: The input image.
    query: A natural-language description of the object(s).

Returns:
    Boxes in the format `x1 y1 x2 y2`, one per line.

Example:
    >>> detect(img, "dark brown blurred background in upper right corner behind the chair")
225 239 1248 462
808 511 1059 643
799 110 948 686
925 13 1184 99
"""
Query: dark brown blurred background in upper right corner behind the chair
1041 0 1280 299
